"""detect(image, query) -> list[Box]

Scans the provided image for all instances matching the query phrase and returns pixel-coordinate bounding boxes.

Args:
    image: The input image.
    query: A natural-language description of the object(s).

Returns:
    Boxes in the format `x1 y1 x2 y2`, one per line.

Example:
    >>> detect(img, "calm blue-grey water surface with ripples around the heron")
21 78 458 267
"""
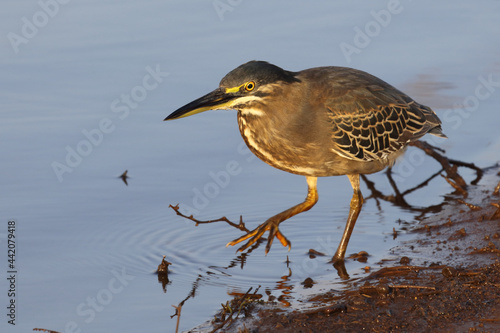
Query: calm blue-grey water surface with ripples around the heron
0 0 500 332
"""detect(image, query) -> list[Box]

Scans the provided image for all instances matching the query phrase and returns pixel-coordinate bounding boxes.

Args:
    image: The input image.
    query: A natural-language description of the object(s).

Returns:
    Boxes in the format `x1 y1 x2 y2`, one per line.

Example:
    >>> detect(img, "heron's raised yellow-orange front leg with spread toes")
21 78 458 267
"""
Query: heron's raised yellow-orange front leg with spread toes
226 177 318 254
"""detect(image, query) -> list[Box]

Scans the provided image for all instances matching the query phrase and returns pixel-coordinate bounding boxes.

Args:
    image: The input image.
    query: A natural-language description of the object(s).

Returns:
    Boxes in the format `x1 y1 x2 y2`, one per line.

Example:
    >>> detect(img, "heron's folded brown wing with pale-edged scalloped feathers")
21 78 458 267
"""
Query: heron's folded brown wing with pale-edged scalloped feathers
325 71 444 161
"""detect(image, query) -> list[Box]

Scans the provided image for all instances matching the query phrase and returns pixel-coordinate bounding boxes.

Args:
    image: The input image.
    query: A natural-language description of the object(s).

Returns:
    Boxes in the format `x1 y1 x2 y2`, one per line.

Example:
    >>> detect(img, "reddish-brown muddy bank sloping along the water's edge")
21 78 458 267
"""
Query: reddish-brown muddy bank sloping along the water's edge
209 170 500 333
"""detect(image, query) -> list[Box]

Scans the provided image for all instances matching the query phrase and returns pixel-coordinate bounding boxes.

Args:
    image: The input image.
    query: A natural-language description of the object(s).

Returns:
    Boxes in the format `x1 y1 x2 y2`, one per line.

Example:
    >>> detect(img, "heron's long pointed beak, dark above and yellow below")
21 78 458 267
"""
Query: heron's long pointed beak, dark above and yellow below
164 88 240 120
